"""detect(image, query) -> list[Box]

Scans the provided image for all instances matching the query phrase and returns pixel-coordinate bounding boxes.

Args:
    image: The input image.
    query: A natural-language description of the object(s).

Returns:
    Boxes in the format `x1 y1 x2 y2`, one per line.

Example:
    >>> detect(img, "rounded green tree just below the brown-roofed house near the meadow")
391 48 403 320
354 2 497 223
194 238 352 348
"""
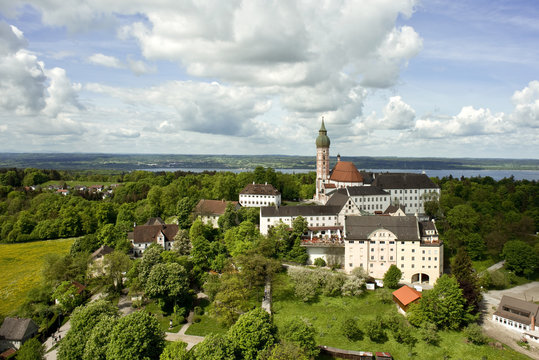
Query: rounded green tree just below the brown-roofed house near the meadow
144 263 189 307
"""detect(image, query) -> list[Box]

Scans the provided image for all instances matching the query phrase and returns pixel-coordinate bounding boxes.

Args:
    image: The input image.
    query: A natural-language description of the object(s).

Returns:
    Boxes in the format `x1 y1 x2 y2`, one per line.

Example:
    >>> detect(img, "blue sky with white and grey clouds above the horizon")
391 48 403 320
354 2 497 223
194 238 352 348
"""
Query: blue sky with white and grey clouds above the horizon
0 0 539 159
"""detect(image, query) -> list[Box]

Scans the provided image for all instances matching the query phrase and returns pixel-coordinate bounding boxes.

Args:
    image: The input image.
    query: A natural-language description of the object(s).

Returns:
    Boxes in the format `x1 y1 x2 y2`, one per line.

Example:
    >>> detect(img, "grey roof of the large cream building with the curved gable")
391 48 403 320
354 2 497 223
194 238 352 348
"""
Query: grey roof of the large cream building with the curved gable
344 216 420 240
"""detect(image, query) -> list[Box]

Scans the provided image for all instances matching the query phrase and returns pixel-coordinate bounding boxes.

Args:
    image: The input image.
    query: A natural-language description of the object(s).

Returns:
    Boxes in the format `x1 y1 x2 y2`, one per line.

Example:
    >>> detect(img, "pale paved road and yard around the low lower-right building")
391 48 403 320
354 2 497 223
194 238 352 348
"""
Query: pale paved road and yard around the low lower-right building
481 282 539 360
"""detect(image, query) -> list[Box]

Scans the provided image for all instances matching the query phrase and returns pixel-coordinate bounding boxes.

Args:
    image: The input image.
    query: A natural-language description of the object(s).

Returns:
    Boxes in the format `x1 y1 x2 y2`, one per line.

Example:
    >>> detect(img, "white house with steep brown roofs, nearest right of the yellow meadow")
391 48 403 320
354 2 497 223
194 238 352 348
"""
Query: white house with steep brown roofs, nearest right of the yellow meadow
127 218 179 256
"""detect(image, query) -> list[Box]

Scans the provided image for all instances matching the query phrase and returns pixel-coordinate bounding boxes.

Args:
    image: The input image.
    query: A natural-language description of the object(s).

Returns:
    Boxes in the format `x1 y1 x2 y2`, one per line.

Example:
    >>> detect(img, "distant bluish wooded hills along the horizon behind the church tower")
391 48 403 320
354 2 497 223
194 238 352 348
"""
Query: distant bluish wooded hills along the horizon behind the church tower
0 153 539 171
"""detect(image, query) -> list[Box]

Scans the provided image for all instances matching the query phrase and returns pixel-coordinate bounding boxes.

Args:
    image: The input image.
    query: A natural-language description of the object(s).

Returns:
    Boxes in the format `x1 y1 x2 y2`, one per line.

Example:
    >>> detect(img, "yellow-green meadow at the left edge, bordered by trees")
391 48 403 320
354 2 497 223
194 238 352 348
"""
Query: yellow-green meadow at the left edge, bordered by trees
0 238 74 315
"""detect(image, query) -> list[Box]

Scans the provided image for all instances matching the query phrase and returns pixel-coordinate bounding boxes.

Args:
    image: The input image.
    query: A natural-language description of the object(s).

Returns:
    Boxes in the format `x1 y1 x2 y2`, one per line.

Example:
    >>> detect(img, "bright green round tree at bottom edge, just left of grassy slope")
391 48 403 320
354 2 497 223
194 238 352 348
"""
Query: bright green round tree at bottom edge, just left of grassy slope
228 308 275 360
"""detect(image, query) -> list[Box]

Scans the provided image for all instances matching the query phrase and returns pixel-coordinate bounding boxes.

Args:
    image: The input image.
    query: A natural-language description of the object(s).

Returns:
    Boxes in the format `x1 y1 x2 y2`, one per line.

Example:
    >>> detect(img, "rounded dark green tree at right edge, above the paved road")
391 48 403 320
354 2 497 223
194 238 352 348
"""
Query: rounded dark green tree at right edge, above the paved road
502 240 539 276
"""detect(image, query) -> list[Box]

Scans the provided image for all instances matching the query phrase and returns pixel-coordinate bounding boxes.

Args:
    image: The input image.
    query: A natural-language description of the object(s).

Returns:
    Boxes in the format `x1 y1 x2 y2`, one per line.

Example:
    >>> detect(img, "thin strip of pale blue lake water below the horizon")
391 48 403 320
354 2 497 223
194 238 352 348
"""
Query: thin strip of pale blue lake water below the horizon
137 168 539 181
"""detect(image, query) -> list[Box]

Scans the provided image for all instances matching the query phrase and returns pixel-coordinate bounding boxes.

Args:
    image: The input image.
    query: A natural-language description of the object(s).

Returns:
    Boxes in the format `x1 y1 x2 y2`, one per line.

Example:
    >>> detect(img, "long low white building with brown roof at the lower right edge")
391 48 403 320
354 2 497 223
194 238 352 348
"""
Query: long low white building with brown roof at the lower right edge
492 295 539 341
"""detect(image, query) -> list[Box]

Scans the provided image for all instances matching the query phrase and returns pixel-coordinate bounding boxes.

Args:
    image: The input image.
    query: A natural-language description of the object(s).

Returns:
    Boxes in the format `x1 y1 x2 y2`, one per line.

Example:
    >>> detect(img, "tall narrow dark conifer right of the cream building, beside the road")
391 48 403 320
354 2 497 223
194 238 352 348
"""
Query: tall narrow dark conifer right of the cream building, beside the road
451 248 482 314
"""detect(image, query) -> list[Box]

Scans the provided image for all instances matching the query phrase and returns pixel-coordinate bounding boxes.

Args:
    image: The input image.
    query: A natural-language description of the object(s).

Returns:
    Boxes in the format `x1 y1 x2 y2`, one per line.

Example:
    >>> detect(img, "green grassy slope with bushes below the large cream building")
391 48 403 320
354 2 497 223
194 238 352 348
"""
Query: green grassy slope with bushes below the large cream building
273 274 528 360
